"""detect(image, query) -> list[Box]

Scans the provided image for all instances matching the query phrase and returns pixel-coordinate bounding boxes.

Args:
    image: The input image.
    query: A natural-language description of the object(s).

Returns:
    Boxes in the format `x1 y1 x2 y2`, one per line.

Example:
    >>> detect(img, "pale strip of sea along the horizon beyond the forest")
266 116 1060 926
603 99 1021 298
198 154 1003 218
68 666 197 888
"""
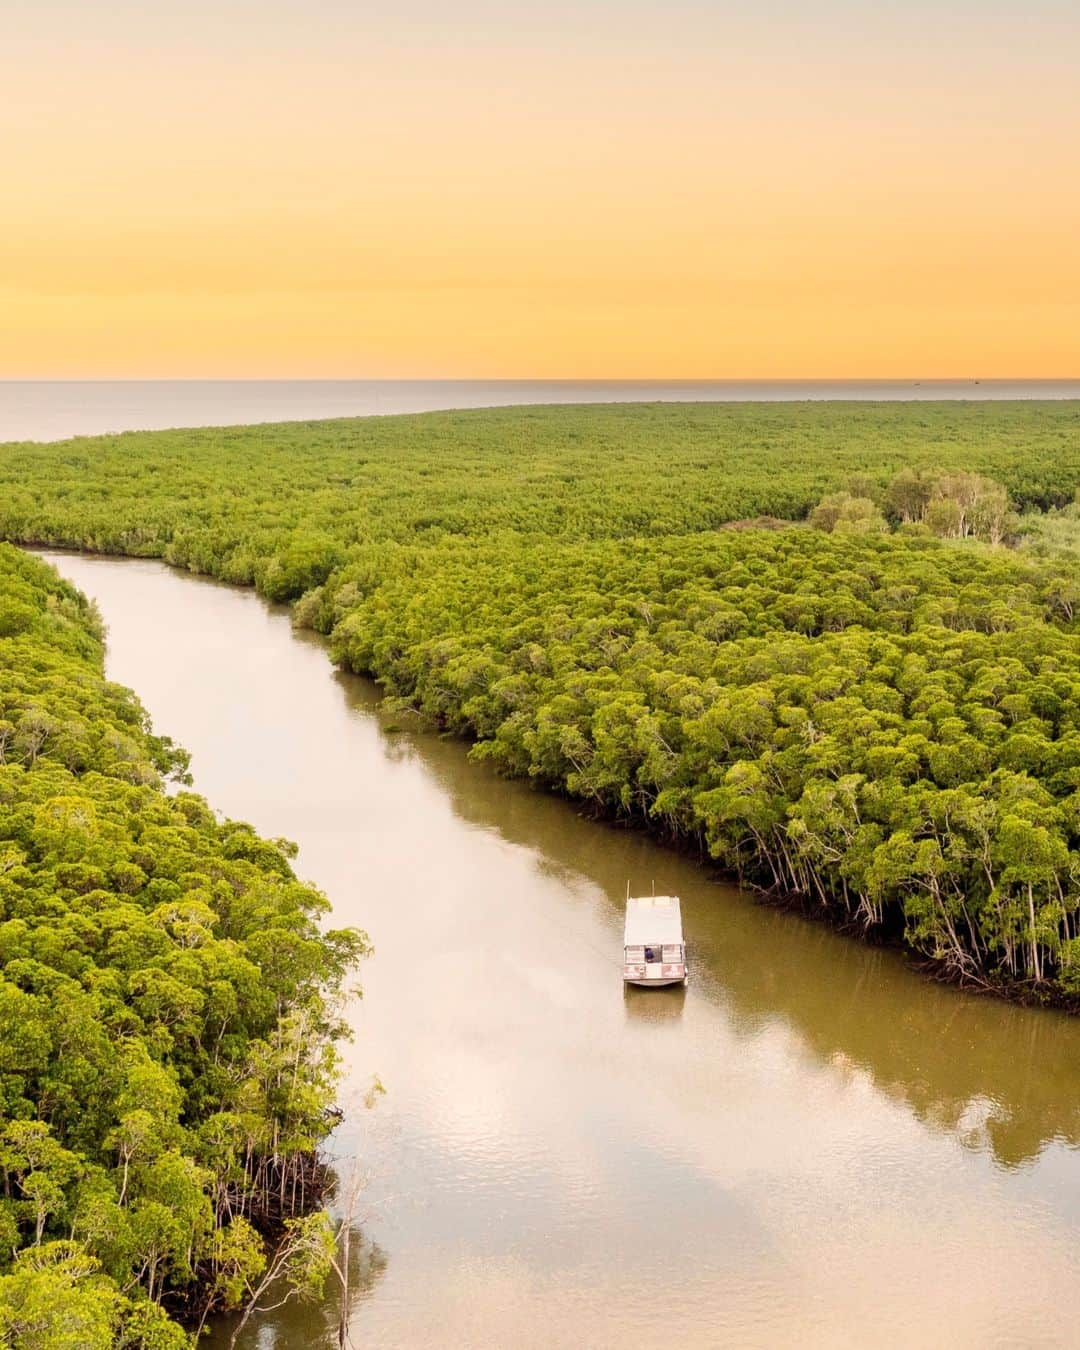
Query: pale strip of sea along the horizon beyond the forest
8 379 1080 443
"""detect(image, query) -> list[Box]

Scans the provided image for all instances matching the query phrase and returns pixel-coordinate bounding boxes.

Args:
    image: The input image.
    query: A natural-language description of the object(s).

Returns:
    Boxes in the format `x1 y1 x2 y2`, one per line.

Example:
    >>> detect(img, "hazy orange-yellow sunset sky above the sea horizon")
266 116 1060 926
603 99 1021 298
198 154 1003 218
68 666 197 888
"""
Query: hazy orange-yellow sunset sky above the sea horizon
0 0 1080 379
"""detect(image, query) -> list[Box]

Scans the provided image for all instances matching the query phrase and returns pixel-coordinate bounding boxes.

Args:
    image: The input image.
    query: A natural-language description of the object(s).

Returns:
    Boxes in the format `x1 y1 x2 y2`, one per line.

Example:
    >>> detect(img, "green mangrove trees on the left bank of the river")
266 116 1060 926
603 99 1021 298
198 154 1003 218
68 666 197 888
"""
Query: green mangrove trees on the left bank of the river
0 545 365 1350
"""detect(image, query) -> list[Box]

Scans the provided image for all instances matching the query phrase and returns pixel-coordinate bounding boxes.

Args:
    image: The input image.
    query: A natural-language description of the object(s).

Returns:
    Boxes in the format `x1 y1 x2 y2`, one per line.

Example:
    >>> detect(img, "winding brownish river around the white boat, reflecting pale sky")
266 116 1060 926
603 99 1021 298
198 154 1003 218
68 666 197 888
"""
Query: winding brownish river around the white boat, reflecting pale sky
37 554 1080 1350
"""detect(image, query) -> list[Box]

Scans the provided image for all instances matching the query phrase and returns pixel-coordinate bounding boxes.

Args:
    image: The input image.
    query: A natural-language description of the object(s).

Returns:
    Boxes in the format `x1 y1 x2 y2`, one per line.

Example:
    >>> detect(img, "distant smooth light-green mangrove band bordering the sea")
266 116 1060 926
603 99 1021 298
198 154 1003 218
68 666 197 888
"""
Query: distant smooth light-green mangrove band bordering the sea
0 401 1080 567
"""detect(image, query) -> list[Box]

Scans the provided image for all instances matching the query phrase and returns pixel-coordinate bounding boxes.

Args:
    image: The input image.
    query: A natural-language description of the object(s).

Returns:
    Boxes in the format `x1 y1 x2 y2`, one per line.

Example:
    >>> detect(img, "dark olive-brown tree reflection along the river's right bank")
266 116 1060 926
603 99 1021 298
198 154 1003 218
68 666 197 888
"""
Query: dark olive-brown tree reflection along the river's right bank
329 658 1080 1166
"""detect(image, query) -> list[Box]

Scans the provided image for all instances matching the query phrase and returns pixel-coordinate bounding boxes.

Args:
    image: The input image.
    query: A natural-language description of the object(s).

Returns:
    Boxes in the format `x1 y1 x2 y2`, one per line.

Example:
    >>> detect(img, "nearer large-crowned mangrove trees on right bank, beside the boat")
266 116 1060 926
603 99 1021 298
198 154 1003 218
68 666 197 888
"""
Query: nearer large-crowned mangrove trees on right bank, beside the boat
313 529 1080 990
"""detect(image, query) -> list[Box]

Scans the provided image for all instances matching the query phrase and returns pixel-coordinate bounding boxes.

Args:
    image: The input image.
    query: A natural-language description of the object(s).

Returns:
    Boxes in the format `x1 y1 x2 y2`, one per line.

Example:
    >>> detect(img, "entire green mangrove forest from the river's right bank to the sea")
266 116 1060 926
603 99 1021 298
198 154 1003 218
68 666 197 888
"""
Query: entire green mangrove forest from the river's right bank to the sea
0 402 1080 998
